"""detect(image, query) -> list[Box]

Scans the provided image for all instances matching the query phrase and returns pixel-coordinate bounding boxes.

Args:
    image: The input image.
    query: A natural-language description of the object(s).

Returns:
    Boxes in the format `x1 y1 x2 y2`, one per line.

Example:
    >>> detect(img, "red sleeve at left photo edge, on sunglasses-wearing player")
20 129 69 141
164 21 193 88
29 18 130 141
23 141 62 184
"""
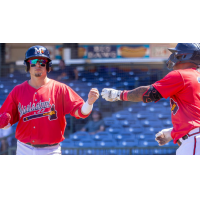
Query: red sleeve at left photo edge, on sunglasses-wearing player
0 88 19 125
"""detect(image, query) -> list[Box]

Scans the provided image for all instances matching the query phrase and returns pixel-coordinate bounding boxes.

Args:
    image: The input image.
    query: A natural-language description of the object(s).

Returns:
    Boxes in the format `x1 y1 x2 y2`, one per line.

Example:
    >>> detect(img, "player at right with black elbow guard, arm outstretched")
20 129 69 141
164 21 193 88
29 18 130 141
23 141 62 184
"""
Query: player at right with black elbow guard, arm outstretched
101 43 200 155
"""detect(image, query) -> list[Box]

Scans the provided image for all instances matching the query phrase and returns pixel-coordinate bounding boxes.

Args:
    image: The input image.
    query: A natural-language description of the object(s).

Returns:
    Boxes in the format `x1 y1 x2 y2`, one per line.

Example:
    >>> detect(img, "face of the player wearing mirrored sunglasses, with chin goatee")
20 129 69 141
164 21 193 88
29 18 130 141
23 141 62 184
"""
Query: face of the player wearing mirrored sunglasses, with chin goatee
30 57 47 77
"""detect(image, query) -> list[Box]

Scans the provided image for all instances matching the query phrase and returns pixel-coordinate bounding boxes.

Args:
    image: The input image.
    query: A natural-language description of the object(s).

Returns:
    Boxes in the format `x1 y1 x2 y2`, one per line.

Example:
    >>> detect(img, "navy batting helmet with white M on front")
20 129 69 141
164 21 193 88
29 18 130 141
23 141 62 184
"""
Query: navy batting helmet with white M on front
24 45 52 67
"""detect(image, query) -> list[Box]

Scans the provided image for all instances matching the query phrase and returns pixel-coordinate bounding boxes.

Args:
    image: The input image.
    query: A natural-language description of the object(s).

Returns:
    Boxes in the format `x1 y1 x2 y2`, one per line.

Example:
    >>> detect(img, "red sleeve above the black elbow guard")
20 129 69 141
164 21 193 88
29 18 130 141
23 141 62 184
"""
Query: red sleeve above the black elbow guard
152 70 184 99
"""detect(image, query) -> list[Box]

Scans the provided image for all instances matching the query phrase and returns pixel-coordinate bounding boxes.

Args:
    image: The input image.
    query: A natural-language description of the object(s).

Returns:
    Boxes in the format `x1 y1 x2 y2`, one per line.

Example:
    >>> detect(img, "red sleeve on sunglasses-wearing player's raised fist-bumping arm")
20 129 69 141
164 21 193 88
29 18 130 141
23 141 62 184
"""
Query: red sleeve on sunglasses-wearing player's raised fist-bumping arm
63 86 85 119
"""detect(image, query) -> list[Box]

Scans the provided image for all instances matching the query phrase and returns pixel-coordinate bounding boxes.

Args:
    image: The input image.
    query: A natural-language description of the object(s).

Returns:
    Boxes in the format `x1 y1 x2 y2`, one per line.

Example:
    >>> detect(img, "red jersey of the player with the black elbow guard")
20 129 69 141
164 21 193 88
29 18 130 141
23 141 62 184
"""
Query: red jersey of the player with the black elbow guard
153 68 200 143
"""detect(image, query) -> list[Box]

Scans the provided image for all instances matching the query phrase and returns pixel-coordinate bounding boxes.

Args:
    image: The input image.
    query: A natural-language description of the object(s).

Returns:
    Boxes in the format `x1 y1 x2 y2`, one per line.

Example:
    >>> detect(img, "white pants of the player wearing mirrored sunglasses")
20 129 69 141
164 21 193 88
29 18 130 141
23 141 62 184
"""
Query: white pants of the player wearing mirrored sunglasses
16 140 61 155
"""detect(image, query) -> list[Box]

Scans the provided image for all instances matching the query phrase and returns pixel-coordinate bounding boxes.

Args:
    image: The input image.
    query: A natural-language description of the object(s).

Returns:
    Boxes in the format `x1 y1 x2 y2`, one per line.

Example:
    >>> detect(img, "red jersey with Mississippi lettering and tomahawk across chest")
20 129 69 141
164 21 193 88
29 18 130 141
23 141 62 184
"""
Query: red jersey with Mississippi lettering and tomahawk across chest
0 80 89 144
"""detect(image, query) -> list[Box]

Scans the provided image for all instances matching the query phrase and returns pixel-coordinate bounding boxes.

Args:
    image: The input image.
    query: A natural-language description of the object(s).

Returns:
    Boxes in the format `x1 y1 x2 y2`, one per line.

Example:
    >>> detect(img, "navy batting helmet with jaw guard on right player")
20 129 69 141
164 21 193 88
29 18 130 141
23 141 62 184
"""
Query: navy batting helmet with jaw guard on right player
166 43 200 69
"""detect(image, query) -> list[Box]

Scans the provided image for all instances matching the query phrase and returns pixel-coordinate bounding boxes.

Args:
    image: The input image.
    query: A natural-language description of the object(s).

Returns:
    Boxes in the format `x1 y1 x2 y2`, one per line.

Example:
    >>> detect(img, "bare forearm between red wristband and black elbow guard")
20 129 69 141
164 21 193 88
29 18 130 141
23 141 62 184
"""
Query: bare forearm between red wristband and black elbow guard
127 85 150 102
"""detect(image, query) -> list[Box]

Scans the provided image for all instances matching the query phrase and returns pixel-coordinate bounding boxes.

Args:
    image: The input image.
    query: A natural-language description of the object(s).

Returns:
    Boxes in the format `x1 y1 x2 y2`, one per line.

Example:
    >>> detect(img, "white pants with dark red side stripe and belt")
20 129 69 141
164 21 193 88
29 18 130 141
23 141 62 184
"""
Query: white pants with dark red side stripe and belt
176 128 200 155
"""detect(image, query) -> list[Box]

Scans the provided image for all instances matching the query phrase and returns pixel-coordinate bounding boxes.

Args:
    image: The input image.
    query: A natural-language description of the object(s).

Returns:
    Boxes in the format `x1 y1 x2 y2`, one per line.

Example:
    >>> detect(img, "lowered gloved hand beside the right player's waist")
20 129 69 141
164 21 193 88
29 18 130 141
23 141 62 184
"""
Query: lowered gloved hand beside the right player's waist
155 128 173 146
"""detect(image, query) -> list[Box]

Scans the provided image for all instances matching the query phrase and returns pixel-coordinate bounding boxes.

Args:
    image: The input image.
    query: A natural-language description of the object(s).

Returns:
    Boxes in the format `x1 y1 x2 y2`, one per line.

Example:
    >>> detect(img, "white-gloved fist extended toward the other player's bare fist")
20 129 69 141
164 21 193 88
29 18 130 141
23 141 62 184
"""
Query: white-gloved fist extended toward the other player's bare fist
101 88 122 102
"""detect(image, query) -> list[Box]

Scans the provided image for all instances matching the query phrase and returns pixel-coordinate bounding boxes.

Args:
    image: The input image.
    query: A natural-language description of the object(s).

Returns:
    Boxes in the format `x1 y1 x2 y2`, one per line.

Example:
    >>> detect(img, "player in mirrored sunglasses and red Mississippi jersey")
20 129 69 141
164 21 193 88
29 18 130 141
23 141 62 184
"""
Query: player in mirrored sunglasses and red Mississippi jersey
0 46 99 155
